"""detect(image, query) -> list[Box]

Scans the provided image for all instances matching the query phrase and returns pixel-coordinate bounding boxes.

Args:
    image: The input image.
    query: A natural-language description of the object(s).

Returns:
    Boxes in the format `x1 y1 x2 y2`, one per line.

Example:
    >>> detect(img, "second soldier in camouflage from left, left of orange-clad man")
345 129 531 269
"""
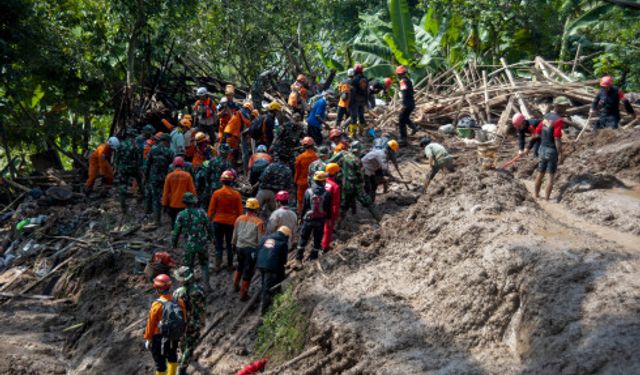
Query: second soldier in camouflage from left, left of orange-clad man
144 133 174 226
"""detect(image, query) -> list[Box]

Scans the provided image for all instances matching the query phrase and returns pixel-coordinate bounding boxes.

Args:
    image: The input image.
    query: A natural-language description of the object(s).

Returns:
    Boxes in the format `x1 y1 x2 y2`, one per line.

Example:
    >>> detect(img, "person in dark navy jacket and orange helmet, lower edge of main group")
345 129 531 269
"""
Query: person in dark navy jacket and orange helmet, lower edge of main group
256 226 292 315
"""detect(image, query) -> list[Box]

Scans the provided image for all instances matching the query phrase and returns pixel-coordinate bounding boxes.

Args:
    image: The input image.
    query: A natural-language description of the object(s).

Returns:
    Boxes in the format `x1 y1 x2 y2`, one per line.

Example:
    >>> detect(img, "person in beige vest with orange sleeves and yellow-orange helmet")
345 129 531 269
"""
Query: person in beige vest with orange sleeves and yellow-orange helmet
231 198 265 301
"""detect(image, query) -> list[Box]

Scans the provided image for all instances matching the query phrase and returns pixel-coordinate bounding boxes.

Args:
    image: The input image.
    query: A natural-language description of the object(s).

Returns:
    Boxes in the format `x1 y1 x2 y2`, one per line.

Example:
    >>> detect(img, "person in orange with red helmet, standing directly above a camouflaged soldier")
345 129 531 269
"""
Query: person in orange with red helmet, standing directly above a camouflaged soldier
162 156 196 227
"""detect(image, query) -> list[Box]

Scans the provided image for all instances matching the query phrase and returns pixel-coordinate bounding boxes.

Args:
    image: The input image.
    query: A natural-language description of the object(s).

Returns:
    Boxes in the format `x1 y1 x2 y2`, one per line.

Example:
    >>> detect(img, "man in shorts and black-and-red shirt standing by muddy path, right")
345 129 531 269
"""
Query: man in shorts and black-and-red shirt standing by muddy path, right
527 96 571 200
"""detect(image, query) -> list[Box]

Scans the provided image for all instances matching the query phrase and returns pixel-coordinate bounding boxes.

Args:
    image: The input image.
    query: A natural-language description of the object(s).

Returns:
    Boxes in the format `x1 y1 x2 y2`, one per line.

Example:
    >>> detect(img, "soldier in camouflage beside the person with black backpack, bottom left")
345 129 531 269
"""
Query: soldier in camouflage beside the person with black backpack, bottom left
173 266 207 375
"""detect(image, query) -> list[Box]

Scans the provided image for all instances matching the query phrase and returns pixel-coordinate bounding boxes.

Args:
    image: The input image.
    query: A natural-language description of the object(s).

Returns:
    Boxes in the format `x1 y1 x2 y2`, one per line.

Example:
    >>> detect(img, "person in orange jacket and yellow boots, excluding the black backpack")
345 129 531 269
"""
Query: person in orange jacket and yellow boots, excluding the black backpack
144 274 187 375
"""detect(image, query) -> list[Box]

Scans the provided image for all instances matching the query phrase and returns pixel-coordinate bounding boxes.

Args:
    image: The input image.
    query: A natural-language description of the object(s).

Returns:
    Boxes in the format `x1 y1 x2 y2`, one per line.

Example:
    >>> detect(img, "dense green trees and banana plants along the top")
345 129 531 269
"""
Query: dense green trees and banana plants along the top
0 0 640 172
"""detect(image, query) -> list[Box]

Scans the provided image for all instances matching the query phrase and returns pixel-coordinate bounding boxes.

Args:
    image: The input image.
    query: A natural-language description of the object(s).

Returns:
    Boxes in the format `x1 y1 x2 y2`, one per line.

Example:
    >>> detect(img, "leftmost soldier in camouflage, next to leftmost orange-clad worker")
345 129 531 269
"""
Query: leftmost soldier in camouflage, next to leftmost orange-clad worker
113 129 144 215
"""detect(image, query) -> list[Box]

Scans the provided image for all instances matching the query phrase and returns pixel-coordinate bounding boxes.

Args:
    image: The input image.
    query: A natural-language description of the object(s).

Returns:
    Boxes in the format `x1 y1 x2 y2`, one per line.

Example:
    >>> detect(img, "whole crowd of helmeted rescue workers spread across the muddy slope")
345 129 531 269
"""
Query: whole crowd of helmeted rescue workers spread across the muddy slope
86 64 633 375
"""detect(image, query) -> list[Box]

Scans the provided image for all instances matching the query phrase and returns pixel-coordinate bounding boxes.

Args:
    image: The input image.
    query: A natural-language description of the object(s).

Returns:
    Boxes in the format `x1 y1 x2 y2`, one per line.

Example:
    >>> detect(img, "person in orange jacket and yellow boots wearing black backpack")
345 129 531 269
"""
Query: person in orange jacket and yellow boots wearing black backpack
144 274 187 375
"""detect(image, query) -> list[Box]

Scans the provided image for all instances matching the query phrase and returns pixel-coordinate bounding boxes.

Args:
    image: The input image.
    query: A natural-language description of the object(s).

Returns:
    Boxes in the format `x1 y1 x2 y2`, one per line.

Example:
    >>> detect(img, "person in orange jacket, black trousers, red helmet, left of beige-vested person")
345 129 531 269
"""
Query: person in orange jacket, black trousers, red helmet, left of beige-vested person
208 170 243 272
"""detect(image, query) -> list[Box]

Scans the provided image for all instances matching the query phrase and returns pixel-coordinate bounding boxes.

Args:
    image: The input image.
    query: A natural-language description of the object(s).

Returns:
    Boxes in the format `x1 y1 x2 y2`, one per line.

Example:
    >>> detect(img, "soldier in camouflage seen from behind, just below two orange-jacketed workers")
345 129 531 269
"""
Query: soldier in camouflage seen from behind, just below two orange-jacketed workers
171 192 213 288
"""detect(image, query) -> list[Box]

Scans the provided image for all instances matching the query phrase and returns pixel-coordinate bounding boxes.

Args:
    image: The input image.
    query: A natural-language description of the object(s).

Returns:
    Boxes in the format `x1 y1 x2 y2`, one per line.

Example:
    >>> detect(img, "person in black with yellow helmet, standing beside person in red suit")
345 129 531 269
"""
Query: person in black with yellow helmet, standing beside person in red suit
296 171 332 269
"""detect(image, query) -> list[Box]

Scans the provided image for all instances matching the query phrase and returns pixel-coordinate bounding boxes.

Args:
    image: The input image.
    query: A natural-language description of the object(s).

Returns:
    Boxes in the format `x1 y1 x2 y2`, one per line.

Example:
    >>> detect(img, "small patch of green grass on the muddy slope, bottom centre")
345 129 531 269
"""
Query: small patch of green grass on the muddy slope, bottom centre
255 286 308 362
